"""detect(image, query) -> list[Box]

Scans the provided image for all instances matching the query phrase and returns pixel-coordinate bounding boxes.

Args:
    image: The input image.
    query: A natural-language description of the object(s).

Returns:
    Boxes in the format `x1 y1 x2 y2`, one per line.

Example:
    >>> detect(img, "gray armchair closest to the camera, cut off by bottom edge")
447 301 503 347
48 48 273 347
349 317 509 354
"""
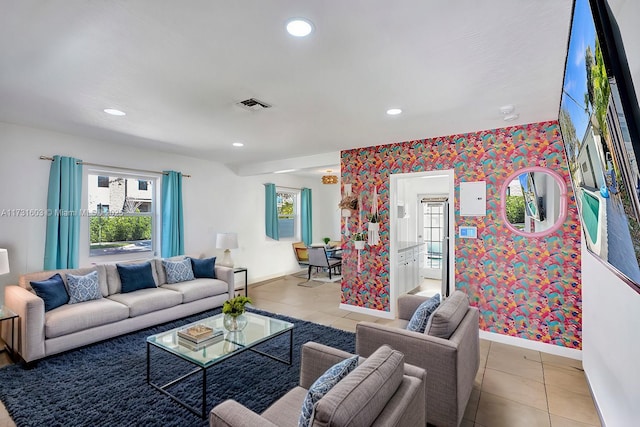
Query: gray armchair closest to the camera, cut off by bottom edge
209 342 426 427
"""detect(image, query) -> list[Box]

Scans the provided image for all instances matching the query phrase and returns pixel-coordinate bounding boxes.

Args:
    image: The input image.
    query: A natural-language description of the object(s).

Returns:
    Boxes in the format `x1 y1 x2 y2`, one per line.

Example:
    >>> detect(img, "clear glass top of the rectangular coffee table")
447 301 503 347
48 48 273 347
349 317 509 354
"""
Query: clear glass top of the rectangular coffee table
147 312 293 367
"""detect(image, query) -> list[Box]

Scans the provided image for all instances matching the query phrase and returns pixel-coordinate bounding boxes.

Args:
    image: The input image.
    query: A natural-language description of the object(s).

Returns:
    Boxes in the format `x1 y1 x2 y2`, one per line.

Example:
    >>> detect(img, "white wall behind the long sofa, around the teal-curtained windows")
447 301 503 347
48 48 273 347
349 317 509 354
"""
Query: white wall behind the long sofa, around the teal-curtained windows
0 123 340 301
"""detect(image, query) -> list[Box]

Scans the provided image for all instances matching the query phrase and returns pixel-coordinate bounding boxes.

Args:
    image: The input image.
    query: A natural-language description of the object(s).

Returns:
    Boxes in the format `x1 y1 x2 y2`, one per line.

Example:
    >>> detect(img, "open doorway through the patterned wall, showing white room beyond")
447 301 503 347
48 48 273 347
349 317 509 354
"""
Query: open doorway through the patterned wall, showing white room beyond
389 169 455 316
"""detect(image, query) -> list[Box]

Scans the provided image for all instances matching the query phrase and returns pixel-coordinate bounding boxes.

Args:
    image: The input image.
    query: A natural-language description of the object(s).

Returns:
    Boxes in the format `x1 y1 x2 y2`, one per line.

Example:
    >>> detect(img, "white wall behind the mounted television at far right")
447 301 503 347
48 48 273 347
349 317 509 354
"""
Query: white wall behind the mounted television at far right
582 0 640 427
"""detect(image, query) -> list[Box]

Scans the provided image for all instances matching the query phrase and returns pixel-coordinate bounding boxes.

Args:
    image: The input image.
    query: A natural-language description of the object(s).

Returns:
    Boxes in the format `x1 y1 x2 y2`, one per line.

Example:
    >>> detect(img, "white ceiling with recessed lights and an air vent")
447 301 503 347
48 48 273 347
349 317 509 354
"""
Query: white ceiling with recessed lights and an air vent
0 0 572 174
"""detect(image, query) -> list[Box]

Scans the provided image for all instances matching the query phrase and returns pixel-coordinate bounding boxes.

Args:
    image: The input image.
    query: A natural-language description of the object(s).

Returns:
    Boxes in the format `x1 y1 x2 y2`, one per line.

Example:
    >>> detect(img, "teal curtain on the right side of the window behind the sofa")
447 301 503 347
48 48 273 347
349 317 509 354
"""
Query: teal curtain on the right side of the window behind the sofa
160 171 184 258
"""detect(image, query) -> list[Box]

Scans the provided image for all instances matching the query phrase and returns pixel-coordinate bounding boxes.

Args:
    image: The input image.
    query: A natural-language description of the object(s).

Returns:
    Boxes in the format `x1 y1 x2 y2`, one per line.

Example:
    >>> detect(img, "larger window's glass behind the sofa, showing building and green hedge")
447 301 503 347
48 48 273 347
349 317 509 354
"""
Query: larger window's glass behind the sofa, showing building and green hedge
87 171 157 259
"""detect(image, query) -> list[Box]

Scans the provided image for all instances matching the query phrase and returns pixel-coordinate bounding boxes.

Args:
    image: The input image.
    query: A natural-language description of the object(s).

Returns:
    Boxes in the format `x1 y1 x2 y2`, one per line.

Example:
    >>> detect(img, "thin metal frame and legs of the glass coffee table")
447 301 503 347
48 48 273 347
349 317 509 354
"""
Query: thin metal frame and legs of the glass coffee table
147 312 294 419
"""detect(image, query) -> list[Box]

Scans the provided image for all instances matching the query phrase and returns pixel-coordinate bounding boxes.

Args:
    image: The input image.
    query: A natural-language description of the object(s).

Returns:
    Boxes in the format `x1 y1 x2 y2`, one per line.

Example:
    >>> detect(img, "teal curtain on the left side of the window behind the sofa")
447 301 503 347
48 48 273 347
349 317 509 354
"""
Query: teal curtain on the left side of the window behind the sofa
44 156 82 270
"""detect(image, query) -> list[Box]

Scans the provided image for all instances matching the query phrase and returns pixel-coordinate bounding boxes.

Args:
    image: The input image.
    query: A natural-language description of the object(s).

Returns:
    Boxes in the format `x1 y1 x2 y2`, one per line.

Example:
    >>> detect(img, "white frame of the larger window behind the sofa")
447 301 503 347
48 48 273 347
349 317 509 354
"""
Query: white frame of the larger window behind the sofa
80 167 162 265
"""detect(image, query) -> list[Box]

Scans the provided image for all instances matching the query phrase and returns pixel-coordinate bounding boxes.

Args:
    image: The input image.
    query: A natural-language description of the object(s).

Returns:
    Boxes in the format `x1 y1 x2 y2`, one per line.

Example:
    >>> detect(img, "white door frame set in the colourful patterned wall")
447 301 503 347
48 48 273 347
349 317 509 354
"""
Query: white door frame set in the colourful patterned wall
389 169 455 315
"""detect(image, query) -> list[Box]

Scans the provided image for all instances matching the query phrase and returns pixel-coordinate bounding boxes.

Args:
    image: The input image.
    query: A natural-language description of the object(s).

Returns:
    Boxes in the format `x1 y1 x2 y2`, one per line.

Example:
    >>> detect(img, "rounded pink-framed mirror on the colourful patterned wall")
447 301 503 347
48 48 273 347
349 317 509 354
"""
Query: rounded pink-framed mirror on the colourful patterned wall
500 166 567 237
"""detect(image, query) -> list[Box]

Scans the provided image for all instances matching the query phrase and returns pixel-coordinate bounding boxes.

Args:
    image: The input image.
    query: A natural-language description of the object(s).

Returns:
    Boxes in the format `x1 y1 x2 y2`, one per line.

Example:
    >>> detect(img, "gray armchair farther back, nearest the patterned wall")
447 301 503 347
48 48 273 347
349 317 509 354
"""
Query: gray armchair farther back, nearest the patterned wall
356 291 480 427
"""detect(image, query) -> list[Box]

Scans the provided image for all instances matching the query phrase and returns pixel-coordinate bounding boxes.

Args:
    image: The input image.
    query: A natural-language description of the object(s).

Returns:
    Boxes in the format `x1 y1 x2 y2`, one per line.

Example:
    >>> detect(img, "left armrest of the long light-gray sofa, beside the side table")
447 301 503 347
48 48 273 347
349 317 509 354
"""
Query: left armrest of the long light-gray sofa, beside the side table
4 285 45 362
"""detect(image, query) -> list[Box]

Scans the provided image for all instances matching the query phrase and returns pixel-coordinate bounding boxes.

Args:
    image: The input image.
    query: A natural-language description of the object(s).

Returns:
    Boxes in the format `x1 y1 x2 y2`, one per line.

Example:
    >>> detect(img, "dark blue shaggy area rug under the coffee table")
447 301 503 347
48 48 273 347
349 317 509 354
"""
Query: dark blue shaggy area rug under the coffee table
0 309 355 427
